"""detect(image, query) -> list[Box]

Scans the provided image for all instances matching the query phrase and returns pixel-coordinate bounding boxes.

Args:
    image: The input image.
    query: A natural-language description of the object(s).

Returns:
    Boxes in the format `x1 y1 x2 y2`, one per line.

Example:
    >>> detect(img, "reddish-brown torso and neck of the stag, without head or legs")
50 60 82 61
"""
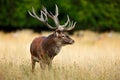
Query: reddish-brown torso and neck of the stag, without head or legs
30 35 62 62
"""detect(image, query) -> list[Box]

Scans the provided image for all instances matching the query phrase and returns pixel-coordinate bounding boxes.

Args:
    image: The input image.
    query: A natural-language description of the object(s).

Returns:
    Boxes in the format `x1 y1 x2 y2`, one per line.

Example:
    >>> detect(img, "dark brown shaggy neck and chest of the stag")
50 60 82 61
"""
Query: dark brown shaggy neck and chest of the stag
42 34 62 57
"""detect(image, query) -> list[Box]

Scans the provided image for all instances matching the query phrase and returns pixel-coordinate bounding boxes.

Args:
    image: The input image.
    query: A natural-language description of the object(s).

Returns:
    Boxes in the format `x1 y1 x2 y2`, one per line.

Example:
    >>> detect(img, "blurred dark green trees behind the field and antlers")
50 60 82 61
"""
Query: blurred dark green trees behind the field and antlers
0 0 120 32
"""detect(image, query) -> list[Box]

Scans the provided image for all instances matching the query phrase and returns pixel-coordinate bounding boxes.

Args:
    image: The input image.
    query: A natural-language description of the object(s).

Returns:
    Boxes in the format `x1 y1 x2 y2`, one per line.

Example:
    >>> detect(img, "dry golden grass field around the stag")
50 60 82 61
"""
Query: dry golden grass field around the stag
0 30 120 80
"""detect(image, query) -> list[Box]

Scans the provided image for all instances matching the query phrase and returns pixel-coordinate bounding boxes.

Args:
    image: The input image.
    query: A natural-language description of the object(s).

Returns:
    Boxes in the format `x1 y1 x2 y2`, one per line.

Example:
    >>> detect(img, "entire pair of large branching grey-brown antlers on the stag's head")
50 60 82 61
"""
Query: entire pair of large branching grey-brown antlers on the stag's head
28 5 76 31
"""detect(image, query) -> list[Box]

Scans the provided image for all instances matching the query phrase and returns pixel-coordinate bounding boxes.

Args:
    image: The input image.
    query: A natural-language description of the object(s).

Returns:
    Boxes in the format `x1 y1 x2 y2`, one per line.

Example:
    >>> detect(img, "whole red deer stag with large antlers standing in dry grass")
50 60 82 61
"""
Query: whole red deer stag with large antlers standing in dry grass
28 5 76 71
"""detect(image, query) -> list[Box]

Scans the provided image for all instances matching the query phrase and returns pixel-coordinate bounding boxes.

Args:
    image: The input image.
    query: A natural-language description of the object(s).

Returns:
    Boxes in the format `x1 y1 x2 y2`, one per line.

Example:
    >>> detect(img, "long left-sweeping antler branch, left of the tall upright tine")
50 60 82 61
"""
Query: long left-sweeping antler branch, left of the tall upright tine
28 7 56 29
